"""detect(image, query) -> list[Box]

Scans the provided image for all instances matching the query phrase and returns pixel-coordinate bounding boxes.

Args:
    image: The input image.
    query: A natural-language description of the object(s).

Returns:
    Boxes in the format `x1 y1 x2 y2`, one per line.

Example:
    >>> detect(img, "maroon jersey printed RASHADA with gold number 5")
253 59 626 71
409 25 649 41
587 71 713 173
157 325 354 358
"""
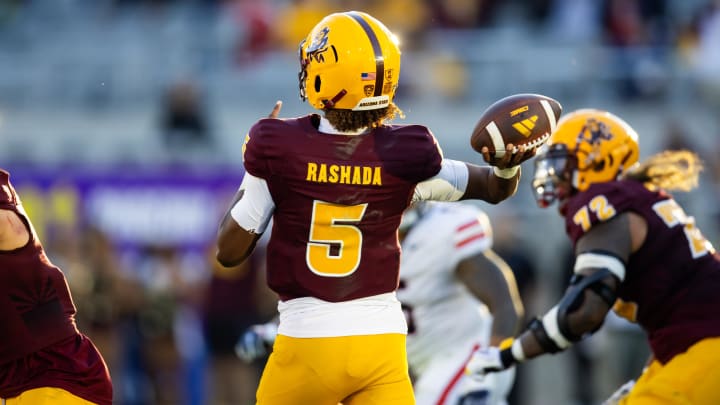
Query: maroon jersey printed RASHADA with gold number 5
244 115 442 302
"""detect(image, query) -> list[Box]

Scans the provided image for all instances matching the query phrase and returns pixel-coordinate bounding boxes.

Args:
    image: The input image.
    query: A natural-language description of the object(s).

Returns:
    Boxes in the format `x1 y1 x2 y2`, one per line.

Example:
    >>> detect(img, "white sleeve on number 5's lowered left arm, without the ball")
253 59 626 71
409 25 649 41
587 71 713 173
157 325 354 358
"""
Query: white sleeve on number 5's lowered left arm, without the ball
230 172 275 234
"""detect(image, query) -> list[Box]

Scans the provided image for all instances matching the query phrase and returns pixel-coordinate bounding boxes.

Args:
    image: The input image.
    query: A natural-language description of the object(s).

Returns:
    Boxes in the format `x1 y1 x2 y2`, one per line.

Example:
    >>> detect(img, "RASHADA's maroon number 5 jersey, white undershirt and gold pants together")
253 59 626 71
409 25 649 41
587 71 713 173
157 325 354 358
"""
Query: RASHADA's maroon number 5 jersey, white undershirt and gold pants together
244 115 442 405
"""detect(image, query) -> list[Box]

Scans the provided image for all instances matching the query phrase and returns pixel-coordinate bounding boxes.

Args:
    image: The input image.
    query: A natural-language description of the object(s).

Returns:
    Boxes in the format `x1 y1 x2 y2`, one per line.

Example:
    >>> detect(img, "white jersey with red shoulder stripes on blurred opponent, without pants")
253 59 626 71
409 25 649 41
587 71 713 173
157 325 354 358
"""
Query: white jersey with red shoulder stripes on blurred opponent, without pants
398 203 492 373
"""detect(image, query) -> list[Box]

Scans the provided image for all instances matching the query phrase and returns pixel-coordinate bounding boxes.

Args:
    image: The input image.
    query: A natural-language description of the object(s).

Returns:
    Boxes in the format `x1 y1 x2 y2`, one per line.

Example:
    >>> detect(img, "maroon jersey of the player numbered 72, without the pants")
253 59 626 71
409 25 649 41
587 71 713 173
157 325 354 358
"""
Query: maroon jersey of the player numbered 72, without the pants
565 180 720 363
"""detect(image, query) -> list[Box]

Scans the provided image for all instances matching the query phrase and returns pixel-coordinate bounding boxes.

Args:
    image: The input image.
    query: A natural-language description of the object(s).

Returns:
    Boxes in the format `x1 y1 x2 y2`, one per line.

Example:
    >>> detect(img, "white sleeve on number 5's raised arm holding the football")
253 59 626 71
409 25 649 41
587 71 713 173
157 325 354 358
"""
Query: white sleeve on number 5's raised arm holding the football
413 159 469 201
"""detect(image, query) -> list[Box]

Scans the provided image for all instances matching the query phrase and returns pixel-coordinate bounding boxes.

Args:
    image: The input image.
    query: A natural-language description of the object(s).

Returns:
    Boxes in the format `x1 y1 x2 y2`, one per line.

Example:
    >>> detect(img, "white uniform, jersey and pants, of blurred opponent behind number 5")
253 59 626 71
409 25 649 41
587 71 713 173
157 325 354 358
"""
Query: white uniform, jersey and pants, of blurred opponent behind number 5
398 203 515 405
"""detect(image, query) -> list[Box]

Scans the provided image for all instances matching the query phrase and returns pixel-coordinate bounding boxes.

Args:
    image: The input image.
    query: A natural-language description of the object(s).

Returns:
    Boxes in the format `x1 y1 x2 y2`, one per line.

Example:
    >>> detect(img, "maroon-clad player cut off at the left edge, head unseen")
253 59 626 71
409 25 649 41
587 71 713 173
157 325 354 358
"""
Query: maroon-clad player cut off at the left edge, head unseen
0 170 112 405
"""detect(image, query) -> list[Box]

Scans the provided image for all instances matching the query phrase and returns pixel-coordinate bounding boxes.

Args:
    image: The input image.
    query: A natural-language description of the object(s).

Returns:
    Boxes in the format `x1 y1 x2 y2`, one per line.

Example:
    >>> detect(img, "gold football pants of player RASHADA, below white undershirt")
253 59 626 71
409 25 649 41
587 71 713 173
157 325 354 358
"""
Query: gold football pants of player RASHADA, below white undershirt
257 334 415 405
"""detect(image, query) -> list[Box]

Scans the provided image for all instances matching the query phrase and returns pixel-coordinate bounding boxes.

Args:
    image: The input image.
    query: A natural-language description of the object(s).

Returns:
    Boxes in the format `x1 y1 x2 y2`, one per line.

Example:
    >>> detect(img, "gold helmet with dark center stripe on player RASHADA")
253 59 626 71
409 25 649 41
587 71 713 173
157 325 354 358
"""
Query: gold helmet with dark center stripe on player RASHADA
298 11 400 111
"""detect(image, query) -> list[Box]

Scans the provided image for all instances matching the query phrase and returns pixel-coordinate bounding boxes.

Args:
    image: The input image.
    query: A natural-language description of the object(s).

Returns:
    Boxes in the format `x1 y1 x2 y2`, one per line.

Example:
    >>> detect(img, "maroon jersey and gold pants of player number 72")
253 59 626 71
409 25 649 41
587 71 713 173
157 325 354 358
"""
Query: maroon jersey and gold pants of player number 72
566 180 720 405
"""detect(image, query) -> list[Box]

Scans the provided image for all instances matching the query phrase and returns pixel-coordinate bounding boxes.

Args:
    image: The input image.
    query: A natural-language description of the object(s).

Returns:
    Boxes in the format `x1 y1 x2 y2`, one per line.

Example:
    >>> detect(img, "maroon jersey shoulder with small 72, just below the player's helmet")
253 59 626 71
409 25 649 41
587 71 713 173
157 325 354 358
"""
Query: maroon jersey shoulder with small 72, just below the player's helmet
565 181 647 241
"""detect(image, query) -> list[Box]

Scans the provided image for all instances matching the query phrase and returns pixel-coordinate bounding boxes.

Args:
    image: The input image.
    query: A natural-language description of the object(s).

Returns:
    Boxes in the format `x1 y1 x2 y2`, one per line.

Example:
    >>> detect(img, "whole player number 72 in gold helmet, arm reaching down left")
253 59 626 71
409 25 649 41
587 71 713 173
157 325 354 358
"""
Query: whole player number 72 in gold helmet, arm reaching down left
467 109 720 405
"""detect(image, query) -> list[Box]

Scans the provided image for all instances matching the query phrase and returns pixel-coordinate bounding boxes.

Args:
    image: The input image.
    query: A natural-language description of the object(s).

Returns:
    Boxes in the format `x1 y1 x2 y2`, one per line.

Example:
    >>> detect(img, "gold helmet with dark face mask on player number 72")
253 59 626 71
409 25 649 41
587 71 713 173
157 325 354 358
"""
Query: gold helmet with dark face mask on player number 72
532 109 640 207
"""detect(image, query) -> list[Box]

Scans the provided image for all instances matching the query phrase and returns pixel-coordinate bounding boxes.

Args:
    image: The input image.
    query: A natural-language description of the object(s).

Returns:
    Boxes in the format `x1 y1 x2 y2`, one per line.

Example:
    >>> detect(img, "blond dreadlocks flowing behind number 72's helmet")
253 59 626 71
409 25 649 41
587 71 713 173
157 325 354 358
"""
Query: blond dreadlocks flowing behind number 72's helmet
624 150 703 191
